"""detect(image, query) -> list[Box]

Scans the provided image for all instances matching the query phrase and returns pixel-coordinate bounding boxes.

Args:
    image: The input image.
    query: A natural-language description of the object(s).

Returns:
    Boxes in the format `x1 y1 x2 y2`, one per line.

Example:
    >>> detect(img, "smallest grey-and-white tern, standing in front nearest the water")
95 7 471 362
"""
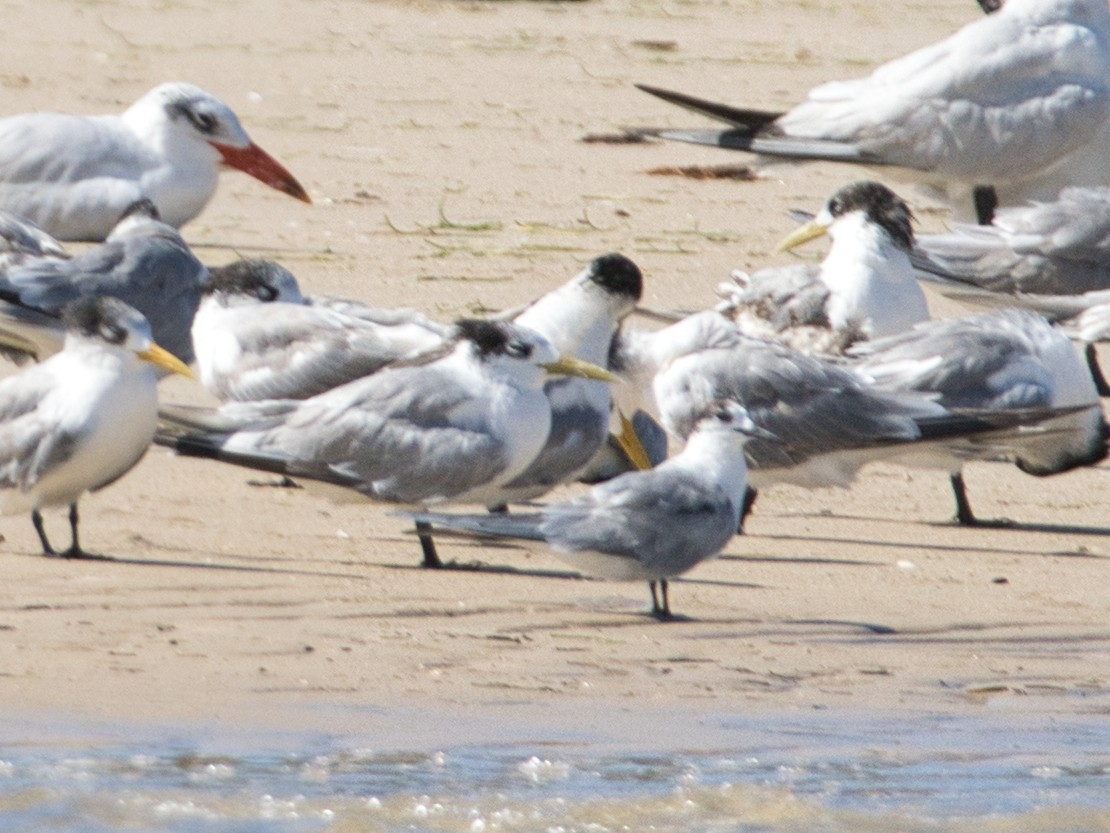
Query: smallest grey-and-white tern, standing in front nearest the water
415 402 774 619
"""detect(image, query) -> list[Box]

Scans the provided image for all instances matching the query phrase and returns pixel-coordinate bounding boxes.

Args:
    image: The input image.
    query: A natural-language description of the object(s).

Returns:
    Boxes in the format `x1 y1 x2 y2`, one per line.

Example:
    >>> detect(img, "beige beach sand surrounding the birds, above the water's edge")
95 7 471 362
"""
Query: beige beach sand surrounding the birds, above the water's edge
0 0 1110 744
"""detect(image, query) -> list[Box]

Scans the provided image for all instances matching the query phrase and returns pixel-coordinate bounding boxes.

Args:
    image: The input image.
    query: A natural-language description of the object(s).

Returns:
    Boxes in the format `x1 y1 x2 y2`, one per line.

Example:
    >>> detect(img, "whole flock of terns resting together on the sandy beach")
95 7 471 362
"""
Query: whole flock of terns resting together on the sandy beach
0 0 1110 619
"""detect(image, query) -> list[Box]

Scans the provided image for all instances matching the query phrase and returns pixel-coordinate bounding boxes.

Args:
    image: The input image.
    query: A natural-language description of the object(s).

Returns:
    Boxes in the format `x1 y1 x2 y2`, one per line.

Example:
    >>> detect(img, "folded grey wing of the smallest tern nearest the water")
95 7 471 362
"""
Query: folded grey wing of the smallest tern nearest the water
539 469 741 576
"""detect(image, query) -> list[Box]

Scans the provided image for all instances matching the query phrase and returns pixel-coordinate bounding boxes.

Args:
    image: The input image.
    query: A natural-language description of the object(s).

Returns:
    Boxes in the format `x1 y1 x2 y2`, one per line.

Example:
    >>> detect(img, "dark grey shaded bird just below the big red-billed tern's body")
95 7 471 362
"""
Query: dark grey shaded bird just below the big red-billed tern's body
0 200 209 363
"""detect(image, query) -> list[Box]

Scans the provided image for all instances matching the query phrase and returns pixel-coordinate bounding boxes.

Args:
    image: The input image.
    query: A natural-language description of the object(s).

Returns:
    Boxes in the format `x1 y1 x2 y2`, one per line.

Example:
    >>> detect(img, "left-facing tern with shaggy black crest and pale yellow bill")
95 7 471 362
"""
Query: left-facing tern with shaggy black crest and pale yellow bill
718 181 929 354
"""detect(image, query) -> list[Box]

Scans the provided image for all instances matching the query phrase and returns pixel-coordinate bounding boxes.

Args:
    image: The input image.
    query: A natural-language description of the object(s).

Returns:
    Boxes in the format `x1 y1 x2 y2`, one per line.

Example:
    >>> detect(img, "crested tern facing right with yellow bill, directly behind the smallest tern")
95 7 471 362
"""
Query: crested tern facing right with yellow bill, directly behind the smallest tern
159 320 613 566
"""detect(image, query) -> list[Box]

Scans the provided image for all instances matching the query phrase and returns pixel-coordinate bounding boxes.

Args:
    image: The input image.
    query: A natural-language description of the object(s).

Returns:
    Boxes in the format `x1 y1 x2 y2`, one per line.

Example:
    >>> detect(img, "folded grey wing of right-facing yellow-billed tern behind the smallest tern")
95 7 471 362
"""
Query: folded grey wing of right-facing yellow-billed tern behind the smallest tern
240 368 509 503
